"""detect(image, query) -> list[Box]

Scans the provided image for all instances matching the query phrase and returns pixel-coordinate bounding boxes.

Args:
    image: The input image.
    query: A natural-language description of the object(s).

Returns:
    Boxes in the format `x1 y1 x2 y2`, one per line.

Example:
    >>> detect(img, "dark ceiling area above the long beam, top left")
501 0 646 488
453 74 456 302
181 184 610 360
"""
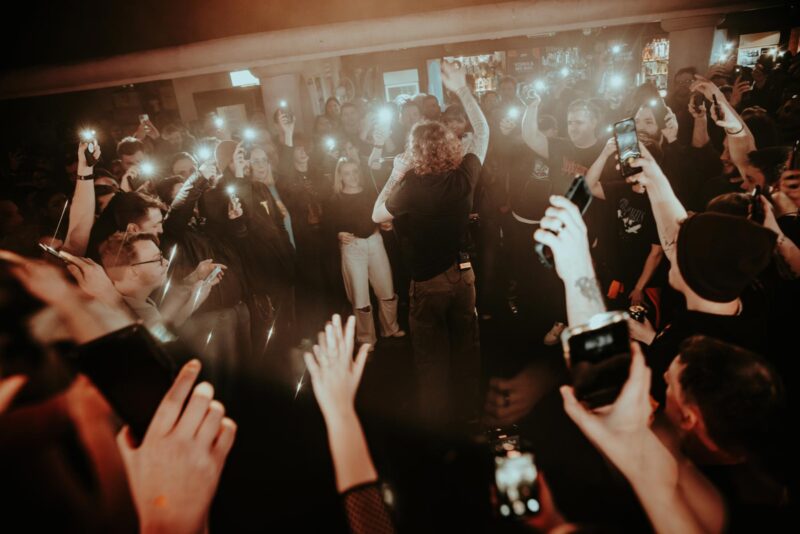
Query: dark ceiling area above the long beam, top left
0 0 506 70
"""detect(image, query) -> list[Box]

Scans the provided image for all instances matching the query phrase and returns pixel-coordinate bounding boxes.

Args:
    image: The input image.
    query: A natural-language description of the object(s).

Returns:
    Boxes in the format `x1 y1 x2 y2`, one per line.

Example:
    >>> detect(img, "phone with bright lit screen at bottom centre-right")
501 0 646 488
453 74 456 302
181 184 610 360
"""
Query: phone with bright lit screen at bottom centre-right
494 450 541 518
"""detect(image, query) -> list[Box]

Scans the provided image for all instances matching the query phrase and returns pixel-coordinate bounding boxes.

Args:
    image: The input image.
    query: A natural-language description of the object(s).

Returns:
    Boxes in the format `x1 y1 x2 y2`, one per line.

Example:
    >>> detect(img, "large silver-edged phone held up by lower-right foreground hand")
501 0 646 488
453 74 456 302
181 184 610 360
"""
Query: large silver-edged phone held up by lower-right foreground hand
561 312 631 408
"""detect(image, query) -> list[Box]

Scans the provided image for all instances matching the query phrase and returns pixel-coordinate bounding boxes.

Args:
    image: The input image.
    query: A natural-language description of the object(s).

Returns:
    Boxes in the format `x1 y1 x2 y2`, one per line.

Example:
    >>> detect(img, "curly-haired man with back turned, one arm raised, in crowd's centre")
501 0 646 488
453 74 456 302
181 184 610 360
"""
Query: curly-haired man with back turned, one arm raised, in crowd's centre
372 63 489 424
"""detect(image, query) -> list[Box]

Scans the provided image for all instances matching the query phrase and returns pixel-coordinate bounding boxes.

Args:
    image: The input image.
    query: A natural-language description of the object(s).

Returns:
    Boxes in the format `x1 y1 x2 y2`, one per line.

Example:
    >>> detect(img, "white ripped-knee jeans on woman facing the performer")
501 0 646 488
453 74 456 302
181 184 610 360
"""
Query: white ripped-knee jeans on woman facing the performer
340 230 400 346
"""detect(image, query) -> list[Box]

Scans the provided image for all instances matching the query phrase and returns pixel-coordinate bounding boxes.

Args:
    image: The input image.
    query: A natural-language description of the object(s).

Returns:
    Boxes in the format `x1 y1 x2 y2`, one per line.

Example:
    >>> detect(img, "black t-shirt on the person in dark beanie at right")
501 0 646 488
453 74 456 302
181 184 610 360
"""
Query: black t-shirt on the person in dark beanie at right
645 287 769 405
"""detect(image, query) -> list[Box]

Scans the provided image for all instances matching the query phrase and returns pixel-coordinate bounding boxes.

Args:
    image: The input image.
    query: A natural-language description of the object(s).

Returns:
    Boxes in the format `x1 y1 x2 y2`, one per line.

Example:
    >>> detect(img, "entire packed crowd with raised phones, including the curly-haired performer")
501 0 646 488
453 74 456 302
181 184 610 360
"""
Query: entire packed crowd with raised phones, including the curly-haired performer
0 45 800 533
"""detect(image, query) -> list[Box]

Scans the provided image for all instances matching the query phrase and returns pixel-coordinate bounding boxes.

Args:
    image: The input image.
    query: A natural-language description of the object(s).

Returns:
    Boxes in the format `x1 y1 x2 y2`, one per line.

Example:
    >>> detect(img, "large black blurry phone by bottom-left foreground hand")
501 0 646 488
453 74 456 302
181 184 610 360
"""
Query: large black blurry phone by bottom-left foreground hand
75 324 177 440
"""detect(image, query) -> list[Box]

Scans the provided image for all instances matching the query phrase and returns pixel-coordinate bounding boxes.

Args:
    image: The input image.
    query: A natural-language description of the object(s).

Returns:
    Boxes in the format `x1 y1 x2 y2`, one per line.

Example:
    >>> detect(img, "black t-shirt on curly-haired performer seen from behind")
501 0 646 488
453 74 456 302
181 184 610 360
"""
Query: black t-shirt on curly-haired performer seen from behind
386 153 481 282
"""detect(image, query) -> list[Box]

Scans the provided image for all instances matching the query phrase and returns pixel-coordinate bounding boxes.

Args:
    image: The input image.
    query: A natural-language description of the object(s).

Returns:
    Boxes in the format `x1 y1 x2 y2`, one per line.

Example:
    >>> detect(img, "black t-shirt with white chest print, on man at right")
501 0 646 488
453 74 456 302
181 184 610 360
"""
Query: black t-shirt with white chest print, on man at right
601 176 660 293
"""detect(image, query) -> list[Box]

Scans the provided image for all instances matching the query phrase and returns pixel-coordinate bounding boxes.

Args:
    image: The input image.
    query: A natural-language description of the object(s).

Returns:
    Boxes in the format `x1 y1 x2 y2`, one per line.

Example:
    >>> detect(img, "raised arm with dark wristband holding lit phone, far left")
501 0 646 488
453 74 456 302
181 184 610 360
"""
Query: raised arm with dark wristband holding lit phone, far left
63 140 100 256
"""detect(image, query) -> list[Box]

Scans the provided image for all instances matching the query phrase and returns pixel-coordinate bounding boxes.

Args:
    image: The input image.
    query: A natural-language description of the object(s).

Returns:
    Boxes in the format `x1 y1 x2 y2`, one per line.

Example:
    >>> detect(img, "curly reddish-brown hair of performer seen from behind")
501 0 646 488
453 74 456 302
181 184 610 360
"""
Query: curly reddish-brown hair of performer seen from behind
408 121 463 175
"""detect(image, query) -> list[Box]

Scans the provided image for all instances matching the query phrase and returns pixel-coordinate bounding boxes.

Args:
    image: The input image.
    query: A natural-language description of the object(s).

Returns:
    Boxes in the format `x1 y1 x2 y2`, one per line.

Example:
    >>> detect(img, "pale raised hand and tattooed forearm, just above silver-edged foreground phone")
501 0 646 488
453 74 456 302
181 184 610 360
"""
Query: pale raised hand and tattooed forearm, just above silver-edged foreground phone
533 197 606 326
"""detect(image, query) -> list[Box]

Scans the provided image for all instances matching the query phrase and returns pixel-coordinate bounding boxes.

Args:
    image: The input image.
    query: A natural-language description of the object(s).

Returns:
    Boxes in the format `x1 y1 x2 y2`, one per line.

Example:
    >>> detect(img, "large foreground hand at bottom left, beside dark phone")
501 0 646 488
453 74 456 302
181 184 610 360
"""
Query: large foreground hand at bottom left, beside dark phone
117 360 236 533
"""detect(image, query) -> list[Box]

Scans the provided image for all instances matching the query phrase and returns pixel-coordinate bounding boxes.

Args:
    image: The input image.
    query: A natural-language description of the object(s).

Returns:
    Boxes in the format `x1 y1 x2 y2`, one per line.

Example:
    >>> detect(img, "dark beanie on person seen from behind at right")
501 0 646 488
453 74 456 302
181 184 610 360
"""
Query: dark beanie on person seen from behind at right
676 213 778 302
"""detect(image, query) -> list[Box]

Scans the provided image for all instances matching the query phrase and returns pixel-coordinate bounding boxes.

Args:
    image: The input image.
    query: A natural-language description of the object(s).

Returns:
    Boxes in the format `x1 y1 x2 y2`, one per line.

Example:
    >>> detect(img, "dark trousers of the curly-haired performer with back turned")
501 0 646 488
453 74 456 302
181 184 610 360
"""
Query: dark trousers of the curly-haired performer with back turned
409 265 480 423
